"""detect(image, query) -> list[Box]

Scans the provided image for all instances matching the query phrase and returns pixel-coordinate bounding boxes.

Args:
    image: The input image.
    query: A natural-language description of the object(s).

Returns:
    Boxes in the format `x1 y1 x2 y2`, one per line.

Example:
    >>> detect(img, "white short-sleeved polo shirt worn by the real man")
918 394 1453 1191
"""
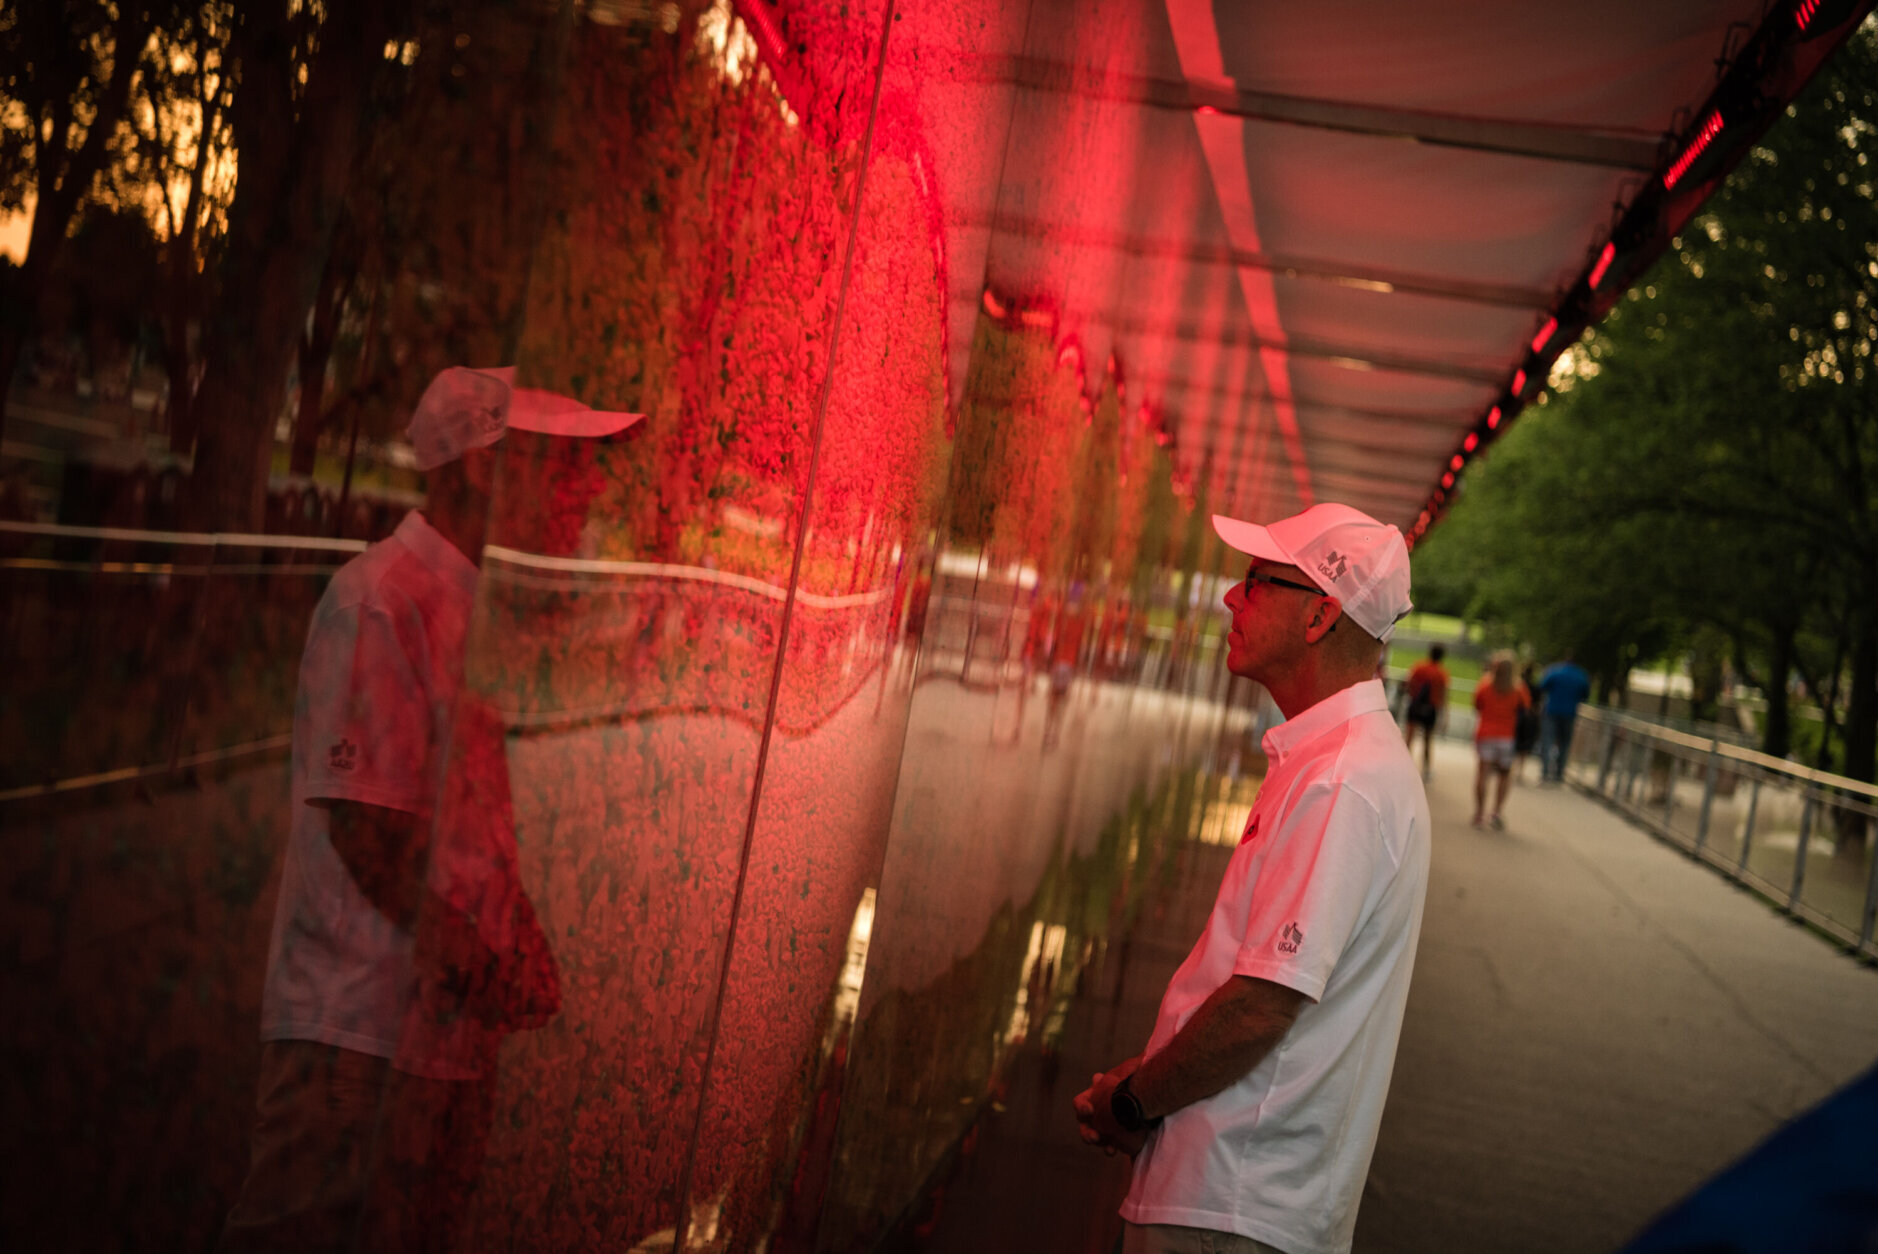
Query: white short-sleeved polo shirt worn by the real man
1121 680 1429 1254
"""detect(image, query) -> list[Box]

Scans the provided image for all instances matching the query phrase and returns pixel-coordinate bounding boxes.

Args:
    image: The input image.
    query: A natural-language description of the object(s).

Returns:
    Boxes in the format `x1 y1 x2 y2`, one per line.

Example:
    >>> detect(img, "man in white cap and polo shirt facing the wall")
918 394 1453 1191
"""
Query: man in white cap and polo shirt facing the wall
1076 505 1429 1254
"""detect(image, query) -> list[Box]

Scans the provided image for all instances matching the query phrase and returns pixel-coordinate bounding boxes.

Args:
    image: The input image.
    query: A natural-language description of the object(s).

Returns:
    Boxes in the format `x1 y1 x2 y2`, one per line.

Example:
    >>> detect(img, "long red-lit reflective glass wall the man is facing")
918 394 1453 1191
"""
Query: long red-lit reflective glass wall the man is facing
0 0 1262 1250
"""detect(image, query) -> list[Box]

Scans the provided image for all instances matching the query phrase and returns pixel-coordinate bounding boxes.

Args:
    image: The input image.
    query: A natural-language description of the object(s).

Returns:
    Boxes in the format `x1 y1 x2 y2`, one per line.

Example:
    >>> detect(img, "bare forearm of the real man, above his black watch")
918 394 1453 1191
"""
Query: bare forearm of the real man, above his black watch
1129 976 1303 1119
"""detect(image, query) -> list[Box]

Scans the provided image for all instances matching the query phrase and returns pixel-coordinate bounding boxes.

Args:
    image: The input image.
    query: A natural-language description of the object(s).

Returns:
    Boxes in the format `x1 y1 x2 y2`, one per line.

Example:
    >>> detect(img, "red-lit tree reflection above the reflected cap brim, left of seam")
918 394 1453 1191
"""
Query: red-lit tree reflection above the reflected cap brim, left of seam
520 30 856 559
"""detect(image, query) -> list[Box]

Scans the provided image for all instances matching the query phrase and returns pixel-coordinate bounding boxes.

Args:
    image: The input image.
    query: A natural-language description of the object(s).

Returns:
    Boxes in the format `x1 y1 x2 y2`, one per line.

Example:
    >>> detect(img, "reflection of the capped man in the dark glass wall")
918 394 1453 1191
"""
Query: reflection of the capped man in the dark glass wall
222 368 637 1250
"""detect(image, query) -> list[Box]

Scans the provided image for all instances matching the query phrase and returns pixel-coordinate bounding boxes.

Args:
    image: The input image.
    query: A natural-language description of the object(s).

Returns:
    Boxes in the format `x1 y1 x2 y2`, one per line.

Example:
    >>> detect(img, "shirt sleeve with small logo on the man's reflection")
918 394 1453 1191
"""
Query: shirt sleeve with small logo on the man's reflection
295 604 434 815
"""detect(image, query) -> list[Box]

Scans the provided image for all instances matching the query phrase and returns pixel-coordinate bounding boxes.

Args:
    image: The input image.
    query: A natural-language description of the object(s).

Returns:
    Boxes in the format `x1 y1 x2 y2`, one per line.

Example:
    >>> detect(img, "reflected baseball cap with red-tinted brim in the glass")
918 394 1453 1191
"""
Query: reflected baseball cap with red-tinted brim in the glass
409 366 646 469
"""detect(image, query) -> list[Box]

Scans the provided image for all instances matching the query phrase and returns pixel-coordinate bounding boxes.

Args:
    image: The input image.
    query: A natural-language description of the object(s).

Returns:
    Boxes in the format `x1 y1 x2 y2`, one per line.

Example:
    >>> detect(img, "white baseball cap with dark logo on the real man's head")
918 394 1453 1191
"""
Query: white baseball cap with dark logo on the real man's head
1213 501 1414 642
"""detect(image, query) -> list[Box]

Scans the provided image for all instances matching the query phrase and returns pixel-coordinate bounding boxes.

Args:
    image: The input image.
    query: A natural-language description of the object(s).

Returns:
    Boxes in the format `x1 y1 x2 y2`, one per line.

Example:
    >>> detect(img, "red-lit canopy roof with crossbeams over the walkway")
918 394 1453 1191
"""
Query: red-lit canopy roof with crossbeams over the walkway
860 0 1869 529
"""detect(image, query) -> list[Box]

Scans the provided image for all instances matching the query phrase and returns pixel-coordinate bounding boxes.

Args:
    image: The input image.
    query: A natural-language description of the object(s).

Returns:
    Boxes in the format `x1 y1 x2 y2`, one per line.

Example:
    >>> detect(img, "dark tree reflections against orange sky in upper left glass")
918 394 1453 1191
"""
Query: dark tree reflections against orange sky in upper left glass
0 0 565 529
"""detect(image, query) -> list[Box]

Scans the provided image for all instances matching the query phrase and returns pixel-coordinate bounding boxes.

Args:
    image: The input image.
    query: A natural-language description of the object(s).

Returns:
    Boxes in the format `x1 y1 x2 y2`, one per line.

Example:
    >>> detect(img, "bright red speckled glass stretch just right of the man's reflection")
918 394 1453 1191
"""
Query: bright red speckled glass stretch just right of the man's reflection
360 4 901 1248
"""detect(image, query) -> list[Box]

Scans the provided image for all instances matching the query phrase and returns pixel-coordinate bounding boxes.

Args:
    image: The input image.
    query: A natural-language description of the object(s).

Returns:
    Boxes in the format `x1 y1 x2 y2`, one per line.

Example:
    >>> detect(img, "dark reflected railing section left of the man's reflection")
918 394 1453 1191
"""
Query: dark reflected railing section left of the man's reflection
0 520 366 805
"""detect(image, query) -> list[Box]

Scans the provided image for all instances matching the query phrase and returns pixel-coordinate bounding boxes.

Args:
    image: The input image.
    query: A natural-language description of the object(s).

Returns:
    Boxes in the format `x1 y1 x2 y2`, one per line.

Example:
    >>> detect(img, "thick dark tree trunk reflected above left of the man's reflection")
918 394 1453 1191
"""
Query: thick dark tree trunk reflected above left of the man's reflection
192 2 389 531
